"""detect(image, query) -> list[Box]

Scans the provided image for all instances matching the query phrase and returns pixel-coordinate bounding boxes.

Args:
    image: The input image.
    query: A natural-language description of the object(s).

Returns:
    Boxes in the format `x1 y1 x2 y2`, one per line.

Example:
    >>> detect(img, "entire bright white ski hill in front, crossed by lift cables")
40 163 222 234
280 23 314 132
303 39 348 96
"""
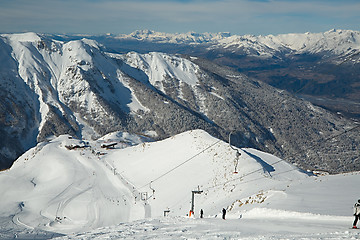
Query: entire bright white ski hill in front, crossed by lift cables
0 130 360 239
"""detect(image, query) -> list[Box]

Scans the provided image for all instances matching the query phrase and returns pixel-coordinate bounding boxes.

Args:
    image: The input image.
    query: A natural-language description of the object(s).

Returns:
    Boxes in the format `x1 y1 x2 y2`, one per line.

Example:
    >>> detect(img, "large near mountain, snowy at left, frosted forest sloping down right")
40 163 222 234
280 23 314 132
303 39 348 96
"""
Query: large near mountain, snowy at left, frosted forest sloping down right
0 33 360 172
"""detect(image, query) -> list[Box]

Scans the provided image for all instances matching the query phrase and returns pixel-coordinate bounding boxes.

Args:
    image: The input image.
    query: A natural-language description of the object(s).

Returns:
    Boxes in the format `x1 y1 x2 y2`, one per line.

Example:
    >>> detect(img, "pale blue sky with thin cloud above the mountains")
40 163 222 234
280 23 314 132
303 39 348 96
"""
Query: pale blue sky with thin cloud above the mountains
0 0 360 35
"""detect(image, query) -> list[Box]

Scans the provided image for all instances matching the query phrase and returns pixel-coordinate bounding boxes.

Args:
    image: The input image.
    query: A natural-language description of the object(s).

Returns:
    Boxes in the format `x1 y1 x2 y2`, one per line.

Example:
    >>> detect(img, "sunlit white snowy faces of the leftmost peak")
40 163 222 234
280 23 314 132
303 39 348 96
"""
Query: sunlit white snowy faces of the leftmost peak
4 33 102 129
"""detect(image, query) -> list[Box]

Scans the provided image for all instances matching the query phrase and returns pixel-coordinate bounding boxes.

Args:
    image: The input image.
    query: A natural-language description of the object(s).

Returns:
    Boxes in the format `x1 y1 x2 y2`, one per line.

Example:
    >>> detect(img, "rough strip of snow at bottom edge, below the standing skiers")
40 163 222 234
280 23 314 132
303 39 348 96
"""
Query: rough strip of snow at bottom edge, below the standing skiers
57 216 360 240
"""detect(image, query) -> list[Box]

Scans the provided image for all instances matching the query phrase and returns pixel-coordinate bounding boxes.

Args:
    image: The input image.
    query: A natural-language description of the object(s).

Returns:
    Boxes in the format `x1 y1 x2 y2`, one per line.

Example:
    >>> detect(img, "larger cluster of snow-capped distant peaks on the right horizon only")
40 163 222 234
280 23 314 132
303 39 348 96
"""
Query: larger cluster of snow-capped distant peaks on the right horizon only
218 30 360 56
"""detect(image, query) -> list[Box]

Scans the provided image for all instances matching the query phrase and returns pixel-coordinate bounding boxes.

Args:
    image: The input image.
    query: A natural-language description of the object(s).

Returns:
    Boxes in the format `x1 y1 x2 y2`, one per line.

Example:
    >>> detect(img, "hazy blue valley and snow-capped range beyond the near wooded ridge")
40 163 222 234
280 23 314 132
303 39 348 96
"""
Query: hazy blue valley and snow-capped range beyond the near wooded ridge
90 29 360 119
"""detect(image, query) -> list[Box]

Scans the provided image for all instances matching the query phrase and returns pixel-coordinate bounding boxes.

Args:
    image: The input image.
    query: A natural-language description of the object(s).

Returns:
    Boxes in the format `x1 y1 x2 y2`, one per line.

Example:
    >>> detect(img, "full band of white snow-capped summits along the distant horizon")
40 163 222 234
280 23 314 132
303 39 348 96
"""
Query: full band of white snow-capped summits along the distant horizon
114 29 360 63
